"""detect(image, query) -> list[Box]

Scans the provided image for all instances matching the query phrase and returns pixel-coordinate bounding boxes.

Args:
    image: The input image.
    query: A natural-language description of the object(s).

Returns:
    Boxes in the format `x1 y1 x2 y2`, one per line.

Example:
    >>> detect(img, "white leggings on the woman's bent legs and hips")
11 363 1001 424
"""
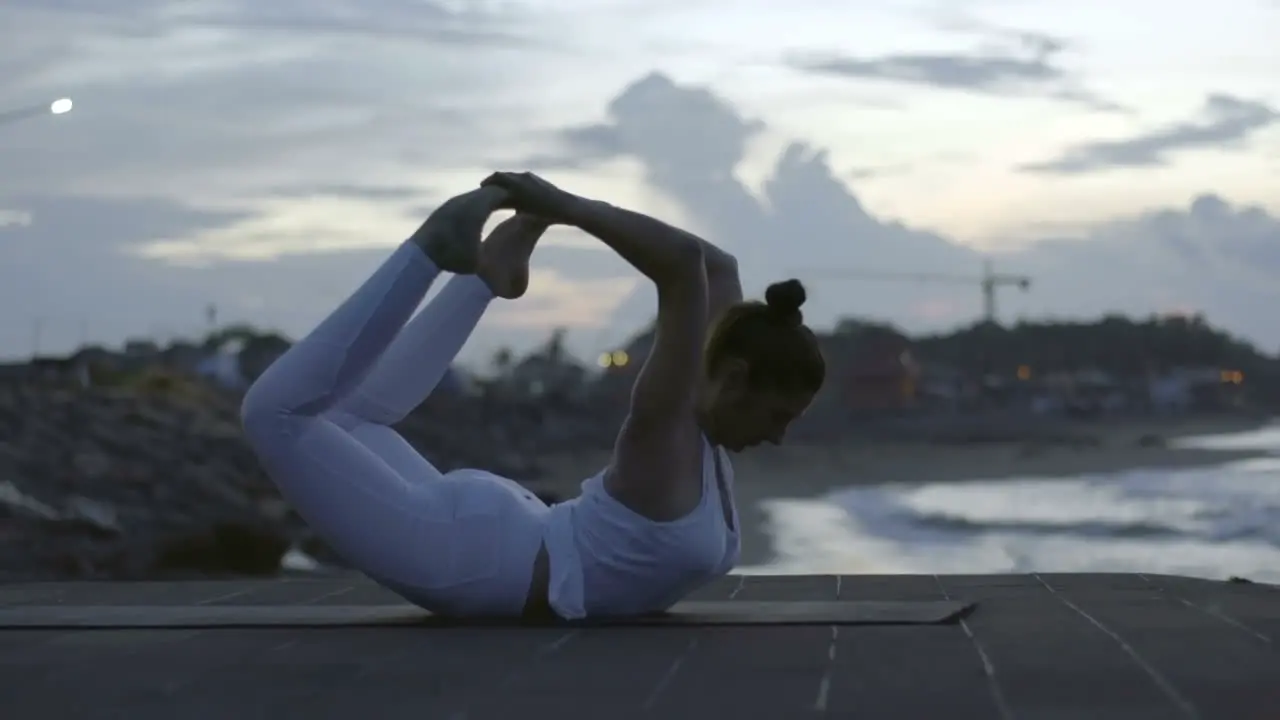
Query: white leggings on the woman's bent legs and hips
242 242 548 616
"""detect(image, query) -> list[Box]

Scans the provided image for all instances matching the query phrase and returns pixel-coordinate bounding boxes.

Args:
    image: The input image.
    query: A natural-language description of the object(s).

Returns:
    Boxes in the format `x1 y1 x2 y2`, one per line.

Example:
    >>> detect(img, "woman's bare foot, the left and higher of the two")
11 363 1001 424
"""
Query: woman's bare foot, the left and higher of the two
412 187 507 275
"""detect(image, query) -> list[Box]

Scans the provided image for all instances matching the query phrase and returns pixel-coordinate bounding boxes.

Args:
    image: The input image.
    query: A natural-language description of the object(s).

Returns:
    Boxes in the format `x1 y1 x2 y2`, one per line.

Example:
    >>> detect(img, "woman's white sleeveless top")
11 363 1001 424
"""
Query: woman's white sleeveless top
545 438 741 620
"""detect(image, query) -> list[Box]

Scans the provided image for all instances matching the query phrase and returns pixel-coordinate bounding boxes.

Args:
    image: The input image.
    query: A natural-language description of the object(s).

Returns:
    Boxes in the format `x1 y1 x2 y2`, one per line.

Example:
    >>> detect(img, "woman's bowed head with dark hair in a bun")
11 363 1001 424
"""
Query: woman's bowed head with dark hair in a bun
703 279 827 451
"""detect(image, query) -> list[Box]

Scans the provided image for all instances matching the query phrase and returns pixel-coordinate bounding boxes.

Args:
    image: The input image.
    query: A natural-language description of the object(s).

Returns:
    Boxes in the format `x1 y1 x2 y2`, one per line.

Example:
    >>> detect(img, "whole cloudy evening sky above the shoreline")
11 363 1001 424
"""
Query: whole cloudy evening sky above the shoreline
0 0 1280 365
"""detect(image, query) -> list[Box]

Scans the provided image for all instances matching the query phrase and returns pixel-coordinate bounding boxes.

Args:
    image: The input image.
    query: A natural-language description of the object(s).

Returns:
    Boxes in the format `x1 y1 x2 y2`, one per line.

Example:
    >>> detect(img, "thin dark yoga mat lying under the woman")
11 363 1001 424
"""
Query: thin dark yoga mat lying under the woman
0 600 972 629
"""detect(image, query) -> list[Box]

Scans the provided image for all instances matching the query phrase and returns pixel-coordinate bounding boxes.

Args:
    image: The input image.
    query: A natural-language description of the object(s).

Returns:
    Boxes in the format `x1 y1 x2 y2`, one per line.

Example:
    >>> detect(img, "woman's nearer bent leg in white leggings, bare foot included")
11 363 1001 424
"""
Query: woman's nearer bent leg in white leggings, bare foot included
242 184 524 604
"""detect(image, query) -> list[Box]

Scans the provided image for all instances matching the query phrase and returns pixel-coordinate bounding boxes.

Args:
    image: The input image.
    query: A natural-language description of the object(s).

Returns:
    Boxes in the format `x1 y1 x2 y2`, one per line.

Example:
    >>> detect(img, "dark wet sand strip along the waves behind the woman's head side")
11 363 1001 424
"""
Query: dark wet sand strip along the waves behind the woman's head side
539 418 1265 565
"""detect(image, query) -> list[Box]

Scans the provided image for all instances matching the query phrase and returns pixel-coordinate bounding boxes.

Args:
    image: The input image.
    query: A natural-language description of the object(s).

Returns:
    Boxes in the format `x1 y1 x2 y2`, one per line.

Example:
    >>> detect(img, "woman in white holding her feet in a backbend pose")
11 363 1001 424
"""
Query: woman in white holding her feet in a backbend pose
242 173 824 620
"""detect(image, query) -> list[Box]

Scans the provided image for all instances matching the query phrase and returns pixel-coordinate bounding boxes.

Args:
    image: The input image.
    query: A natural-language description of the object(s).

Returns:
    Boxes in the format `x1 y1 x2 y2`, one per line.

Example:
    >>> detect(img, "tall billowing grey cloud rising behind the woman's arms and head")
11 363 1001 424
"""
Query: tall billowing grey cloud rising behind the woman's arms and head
524 73 980 328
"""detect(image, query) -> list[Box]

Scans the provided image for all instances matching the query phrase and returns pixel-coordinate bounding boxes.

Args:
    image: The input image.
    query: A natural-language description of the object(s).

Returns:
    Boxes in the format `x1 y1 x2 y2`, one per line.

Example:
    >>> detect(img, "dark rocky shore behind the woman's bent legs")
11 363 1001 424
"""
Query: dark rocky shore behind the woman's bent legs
0 379 609 580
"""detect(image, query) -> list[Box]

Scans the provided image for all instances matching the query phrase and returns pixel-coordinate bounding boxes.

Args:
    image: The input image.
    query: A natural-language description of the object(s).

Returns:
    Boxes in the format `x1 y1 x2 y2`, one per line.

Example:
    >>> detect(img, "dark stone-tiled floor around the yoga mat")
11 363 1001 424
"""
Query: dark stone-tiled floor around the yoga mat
0 574 1280 720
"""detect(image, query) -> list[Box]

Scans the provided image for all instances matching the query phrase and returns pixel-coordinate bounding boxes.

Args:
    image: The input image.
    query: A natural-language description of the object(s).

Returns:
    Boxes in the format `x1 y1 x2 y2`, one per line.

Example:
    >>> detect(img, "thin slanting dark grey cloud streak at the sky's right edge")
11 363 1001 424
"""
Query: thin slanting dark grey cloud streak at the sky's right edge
1021 95 1280 174
